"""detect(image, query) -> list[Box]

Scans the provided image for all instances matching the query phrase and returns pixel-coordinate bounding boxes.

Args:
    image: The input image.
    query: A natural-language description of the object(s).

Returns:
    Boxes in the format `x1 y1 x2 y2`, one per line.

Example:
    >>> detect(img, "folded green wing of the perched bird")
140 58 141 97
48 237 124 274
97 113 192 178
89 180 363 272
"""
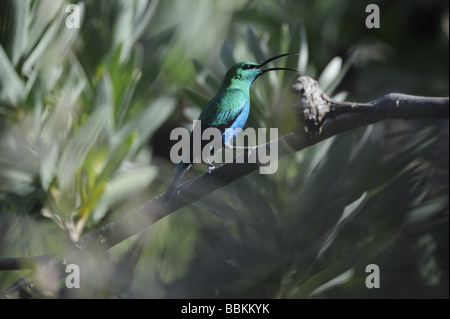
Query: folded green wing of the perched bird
199 89 247 131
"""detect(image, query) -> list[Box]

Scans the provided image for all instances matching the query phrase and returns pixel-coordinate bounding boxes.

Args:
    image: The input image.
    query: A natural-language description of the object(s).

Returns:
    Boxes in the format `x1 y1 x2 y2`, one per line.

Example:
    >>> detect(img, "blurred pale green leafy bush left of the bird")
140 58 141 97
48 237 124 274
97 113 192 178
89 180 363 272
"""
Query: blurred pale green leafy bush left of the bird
1 1 175 241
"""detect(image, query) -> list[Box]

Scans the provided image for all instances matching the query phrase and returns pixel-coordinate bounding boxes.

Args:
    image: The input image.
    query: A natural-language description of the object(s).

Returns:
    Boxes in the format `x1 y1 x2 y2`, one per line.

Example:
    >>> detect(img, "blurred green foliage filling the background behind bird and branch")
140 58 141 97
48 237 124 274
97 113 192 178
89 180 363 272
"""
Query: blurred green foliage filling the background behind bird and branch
0 0 449 298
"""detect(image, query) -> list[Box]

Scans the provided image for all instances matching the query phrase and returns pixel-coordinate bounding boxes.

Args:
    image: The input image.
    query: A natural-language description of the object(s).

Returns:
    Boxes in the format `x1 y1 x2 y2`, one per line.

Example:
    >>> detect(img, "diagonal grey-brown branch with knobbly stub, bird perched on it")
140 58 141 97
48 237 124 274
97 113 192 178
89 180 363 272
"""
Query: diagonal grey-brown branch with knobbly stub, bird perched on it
2 77 449 298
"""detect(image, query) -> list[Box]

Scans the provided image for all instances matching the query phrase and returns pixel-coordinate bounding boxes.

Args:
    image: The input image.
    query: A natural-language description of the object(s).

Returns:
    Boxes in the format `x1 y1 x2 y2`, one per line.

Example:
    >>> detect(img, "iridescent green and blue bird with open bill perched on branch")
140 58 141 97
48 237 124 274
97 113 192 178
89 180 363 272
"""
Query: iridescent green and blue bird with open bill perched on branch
166 53 299 198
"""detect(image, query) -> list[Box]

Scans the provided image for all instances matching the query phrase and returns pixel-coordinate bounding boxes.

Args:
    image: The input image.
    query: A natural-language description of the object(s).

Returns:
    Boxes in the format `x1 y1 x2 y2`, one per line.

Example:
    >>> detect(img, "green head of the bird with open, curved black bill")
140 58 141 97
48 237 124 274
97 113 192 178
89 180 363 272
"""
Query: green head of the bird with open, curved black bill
224 53 299 87
